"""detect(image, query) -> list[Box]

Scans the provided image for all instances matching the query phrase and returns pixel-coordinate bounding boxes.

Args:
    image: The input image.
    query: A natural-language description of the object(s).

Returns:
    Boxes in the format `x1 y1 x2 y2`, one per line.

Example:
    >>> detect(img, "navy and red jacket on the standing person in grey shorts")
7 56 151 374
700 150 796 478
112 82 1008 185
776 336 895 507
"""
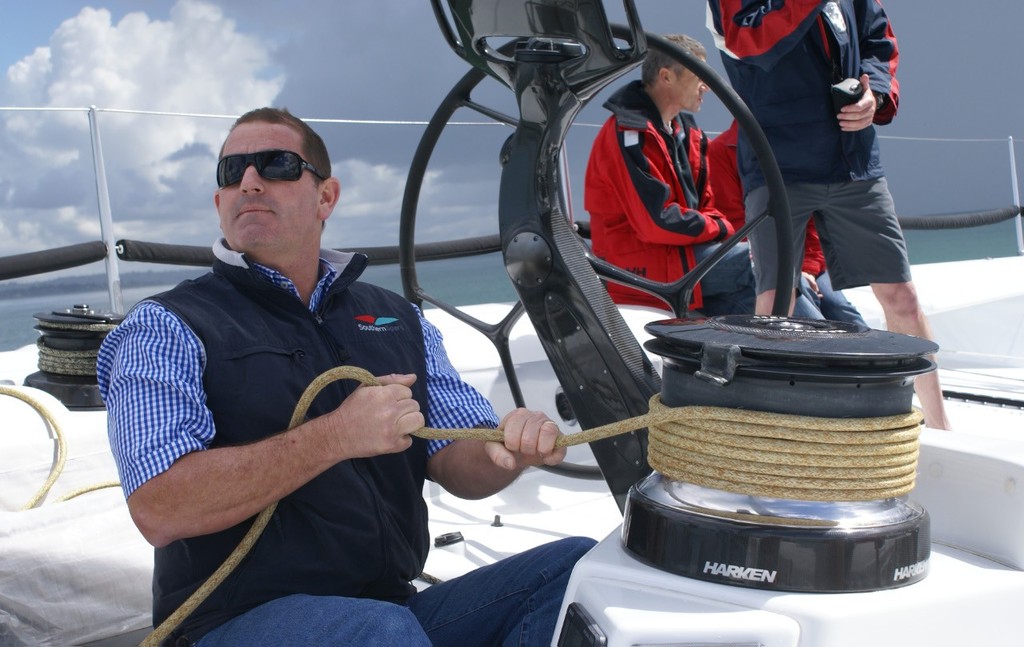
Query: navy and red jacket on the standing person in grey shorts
709 0 899 191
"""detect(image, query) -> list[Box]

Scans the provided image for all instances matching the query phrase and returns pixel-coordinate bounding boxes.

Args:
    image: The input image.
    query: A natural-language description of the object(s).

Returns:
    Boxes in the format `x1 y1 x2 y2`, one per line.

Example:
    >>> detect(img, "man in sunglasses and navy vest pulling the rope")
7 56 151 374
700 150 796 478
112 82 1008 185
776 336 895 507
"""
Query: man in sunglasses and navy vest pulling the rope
97 109 594 646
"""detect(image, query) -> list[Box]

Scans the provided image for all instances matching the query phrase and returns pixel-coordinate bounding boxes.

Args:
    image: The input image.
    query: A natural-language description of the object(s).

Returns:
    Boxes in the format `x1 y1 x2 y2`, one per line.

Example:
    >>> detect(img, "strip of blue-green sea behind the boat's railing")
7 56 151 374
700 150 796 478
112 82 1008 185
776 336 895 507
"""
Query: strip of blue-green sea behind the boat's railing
0 221 1017 351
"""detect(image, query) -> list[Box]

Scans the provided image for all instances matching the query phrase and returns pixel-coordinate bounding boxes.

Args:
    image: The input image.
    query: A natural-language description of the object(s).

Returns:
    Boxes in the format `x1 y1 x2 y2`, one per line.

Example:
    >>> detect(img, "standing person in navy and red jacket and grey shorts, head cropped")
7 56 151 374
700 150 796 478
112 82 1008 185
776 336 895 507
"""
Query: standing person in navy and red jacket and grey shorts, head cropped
709 0 950 429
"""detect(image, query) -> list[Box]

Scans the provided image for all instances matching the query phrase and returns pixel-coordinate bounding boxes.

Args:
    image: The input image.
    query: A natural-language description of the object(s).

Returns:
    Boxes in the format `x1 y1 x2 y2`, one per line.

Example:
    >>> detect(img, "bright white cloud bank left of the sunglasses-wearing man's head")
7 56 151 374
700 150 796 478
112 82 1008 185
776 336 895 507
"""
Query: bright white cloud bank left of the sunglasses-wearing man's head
0 0 285 254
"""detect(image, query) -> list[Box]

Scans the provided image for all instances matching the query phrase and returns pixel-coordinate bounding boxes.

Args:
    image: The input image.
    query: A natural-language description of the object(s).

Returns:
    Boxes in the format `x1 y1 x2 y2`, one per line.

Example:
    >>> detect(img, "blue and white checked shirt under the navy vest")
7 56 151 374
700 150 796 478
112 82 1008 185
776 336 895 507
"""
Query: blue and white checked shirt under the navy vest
96 254 498 497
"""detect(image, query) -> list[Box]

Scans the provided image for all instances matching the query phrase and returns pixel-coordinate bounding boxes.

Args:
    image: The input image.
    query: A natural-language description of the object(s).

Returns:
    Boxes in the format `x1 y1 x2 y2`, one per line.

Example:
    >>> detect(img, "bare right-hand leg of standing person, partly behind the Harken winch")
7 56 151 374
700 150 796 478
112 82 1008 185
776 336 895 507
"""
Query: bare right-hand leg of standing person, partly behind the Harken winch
872 283 952 429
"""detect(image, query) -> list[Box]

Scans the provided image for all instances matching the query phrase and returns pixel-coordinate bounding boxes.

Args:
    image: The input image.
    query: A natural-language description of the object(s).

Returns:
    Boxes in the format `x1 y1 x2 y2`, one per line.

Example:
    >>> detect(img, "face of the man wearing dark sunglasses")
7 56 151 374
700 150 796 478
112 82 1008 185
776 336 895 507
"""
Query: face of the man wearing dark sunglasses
213 122 337 268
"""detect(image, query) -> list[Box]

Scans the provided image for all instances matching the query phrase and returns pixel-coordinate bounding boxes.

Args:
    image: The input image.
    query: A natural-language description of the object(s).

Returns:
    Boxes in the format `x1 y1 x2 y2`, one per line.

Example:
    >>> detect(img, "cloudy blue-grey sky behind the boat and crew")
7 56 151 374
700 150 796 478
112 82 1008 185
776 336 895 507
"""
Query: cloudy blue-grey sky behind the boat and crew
0 0 1024 268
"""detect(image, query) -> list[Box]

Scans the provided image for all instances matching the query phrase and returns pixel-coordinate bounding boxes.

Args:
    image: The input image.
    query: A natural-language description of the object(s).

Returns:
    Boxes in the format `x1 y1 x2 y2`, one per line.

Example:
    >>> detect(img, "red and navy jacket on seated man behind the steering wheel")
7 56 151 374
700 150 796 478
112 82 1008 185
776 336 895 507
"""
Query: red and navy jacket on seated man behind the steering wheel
584 81 733 309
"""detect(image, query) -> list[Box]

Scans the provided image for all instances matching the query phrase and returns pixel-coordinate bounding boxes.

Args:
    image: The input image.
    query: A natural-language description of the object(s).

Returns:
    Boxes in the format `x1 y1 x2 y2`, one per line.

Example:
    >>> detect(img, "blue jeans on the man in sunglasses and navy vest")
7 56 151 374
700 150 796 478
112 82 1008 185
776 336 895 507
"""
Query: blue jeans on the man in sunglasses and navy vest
198 537 595 647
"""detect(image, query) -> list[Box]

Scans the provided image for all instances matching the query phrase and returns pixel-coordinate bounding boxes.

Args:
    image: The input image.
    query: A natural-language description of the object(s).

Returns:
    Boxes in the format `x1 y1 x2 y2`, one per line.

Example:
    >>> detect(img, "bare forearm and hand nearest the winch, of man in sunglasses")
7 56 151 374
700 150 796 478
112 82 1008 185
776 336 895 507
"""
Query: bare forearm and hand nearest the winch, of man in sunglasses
427 408 565 499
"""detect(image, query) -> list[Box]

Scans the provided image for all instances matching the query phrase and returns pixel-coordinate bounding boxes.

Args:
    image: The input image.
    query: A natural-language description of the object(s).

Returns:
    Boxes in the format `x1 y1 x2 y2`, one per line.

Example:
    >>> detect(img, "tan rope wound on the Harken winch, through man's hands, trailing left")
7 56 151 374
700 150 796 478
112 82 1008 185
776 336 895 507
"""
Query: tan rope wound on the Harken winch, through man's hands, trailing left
0 366 922 646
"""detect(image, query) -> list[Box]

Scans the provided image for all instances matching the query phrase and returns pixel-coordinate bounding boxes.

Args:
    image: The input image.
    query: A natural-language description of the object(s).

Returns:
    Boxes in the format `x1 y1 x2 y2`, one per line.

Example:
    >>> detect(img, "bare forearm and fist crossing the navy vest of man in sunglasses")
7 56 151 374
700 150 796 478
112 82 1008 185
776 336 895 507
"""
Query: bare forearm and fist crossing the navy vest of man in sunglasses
128 375 424 547
